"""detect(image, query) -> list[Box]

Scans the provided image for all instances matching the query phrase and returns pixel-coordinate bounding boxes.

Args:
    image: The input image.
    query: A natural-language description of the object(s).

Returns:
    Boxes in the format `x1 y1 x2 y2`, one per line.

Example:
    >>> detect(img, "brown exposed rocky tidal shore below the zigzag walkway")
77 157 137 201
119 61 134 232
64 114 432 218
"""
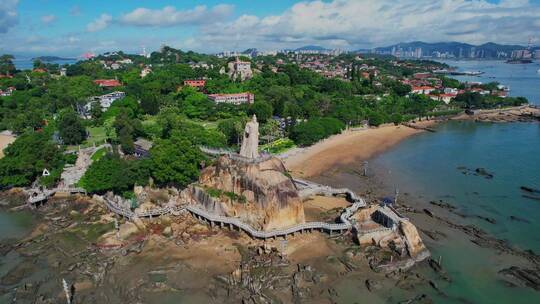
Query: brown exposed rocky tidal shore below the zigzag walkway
0 184 442 303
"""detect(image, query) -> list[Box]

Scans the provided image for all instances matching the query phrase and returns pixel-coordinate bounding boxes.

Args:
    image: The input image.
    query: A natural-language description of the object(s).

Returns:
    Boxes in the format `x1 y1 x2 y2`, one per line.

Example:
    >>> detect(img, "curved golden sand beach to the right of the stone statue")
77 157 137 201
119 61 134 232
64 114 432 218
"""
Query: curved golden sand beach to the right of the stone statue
284 121 435 178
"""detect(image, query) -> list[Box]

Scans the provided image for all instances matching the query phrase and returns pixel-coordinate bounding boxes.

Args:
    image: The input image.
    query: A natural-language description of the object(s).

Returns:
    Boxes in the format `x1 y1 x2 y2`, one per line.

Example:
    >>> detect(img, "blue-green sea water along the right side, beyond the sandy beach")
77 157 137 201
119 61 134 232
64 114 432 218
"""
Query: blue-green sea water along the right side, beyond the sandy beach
372 61 540 304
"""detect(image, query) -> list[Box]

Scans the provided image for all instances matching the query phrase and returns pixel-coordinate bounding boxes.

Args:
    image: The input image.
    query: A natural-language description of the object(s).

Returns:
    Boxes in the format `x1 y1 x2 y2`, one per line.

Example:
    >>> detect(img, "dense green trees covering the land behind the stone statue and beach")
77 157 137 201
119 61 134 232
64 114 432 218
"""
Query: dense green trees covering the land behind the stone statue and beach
0 47 526 195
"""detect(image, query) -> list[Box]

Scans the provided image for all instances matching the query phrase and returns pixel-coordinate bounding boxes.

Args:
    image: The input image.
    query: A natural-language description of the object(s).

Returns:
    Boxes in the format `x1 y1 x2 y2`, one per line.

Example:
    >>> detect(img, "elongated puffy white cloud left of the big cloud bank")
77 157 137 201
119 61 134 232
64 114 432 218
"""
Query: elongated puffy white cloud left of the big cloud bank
120 4 233 26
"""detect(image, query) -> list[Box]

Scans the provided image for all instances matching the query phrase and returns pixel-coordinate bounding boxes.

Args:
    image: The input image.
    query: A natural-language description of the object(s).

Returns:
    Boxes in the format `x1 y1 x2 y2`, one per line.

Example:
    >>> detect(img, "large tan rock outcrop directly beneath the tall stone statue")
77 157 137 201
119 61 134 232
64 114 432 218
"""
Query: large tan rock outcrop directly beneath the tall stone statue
191 156 305 231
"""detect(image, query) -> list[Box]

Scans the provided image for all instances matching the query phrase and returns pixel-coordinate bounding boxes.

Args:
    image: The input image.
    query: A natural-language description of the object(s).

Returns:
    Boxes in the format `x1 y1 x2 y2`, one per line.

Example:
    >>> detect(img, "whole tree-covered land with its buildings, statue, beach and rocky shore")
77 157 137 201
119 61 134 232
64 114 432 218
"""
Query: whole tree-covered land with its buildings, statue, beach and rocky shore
0 47 540 303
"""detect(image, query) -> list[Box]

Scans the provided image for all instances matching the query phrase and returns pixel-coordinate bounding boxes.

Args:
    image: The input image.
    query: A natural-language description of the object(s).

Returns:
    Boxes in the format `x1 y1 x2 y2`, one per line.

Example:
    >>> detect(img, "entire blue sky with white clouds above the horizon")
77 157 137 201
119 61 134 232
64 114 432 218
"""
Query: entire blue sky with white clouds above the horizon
0 0 540 56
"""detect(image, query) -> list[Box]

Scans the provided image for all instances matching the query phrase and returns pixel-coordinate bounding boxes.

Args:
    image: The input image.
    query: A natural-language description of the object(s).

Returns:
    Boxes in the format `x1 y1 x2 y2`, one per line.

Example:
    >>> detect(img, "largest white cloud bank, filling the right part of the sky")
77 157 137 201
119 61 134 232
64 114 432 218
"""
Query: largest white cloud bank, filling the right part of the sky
199 0 540 48
